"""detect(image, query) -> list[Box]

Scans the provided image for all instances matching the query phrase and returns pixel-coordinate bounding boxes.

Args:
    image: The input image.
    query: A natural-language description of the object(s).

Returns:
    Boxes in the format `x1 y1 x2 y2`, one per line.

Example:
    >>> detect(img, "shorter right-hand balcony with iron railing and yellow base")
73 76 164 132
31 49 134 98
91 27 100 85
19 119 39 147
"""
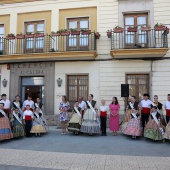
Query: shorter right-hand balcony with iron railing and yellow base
110 28 169 59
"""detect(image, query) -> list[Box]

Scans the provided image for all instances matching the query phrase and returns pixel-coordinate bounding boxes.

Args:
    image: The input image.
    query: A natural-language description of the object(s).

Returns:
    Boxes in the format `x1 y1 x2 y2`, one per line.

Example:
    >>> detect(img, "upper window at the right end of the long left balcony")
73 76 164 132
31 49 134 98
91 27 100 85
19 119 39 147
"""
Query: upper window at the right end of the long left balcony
67 17 89 50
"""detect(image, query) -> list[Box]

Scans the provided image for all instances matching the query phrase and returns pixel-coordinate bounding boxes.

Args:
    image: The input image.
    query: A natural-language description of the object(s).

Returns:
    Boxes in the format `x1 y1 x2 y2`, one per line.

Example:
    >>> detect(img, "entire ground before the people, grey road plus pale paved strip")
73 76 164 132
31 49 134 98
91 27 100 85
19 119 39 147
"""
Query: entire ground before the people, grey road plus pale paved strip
0 127 170 170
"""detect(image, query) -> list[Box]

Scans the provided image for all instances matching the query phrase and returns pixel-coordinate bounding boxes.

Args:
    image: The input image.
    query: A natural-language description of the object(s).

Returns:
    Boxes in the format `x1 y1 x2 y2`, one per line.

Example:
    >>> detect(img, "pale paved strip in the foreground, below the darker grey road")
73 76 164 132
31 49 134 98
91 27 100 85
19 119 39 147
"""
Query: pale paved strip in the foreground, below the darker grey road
0 149 170 170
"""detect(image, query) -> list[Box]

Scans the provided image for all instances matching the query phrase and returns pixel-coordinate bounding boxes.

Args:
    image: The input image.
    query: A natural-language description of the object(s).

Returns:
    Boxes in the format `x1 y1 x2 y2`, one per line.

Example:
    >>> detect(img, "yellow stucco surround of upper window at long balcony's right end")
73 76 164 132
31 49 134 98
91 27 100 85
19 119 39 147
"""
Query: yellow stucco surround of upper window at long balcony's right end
59 7 97 31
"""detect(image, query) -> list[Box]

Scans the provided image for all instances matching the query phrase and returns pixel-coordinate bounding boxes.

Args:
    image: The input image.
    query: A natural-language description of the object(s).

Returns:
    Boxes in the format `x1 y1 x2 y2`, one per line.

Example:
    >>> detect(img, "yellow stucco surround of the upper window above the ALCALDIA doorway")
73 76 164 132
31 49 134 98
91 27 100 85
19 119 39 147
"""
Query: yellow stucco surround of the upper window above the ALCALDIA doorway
17 11 51 34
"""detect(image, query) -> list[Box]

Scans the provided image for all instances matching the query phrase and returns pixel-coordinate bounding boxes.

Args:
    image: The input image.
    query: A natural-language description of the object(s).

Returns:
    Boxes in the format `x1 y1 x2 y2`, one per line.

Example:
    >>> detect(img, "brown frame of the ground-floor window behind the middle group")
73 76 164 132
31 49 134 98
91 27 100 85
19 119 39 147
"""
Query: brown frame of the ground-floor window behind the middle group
67 74 89 108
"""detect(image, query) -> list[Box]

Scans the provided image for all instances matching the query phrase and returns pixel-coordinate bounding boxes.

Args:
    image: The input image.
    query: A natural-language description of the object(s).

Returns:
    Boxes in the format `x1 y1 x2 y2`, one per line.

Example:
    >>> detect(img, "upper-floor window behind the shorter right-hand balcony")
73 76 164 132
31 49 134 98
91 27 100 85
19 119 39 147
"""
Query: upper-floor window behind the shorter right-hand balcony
124 13 148 48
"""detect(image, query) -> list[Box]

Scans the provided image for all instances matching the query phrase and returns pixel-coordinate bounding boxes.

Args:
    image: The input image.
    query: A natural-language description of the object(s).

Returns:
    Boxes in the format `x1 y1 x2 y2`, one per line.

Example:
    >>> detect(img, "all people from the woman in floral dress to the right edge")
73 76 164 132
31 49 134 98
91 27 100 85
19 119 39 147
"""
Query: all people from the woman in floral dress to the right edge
59 93 170 141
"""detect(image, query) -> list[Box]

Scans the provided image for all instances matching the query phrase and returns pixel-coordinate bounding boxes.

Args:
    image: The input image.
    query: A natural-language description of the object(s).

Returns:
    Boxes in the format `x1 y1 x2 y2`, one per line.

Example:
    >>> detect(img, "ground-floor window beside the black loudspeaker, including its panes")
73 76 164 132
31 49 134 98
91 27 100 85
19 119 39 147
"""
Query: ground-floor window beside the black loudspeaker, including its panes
126 74 149 101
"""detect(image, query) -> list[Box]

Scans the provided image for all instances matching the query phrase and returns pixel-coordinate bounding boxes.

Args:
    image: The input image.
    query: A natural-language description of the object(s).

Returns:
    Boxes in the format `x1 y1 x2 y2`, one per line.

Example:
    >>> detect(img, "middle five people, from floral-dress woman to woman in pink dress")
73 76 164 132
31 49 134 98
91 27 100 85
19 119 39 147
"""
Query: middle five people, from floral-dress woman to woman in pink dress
59 94 120 136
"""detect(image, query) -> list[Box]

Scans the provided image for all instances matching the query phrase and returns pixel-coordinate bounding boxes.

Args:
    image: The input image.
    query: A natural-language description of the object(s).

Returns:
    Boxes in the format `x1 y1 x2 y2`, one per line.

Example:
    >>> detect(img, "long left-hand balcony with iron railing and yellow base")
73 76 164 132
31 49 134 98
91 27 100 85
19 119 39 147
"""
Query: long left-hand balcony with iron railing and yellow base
0 32 97 63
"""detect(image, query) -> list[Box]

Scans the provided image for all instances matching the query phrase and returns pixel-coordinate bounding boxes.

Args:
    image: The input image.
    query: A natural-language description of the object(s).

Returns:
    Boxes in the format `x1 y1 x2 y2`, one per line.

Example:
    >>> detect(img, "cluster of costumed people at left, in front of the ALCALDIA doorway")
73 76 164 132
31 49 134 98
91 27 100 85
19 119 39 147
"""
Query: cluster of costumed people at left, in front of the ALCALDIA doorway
0 94 47 141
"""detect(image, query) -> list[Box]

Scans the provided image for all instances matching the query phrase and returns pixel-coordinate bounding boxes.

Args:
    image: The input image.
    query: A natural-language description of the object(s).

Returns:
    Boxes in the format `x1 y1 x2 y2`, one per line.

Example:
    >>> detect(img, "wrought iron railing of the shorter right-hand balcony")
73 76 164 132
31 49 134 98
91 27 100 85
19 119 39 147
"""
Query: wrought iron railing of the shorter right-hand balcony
111 29 169 50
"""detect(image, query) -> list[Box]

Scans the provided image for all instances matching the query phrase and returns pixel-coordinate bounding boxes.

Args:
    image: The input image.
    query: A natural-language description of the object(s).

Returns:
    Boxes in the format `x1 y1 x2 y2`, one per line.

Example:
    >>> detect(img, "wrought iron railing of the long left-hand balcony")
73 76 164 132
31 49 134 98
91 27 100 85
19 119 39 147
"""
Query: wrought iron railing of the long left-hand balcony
0 32 96 55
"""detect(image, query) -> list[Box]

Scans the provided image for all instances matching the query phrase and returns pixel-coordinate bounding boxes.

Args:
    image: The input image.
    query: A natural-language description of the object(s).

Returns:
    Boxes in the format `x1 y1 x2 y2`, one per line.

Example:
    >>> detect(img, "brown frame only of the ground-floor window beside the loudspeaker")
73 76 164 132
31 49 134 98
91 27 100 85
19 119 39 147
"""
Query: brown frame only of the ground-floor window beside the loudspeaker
126 73 150 101
